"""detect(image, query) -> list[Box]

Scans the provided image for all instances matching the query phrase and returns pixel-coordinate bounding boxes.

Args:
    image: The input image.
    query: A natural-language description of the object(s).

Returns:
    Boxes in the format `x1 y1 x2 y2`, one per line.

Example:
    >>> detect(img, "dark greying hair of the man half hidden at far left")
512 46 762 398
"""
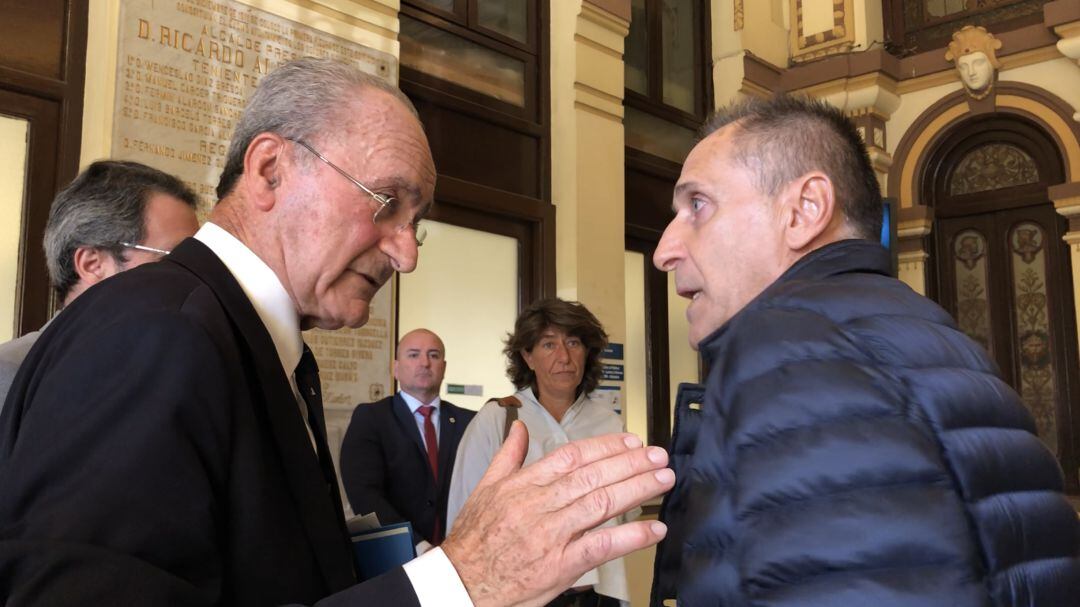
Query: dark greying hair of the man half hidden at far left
44 160 198 301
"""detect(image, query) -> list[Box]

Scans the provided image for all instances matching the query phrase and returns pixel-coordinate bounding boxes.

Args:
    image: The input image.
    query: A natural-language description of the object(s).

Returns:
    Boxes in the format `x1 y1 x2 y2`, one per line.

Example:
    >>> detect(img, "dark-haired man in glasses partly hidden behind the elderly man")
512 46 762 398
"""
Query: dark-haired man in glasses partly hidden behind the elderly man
0 160 199 408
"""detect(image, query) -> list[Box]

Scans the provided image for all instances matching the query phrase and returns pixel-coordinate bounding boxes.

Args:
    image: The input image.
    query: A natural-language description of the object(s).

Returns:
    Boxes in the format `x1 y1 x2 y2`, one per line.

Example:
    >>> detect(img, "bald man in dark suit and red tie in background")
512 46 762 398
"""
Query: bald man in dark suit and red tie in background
341 328 475 545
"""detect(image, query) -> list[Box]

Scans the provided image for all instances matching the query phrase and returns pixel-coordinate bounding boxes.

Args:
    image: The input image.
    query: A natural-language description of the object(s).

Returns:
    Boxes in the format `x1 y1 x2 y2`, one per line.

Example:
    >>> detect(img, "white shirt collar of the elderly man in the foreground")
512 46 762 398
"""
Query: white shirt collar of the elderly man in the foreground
194 221 303 377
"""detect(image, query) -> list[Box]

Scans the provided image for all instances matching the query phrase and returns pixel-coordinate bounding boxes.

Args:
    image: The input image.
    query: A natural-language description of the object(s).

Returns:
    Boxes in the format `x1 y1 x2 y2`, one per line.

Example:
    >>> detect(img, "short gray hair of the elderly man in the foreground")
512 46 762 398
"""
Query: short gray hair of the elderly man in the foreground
217 57 418 200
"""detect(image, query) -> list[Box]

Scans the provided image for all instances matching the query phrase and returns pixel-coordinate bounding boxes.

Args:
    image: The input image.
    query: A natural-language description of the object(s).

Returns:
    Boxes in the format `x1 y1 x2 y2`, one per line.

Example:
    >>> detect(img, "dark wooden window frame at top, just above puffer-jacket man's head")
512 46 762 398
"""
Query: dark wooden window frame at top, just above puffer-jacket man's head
624 0 713 130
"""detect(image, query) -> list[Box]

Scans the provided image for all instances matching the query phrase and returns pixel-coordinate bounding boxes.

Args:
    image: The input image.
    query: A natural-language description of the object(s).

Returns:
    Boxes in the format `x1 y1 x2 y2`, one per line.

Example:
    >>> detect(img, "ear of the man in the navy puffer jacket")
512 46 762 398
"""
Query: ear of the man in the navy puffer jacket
783 172 838 251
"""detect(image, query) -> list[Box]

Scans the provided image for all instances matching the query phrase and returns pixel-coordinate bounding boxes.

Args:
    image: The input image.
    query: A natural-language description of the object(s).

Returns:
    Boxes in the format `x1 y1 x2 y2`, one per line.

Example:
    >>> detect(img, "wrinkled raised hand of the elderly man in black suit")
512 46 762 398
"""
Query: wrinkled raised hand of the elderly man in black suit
443 421 675 607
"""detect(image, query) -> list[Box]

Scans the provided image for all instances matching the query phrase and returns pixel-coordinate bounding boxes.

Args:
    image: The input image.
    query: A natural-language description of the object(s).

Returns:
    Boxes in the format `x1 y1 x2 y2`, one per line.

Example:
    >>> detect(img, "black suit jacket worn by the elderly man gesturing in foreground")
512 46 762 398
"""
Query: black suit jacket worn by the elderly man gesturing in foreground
0 239 416 606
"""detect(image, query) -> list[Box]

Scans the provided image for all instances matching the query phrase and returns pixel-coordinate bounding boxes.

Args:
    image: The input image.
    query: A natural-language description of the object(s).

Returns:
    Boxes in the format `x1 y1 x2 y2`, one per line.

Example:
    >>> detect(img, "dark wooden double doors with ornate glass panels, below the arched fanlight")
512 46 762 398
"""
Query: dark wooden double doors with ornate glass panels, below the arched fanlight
937 204 1077 455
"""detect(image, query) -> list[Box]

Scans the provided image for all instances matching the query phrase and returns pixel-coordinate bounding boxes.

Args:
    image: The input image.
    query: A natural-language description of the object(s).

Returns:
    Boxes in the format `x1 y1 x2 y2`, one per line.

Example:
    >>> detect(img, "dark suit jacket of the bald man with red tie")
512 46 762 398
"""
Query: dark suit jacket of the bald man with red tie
340 394 476 541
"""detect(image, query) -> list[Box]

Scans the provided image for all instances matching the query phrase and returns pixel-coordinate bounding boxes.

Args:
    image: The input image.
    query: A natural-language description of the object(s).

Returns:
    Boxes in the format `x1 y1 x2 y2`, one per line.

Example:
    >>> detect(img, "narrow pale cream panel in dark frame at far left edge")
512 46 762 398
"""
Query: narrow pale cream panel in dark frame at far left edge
0 114 29 342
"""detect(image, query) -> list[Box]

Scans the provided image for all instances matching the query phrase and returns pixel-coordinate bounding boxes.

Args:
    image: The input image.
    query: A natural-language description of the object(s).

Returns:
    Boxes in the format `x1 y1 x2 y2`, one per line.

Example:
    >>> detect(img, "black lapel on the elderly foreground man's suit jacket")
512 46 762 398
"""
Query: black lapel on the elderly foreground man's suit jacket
166 239 356 590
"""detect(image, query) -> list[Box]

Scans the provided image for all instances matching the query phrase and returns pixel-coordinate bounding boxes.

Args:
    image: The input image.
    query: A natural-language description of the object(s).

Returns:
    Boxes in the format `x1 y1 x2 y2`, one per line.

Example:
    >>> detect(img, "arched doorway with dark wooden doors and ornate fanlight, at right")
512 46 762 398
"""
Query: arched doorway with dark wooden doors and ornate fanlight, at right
921 113 1080 494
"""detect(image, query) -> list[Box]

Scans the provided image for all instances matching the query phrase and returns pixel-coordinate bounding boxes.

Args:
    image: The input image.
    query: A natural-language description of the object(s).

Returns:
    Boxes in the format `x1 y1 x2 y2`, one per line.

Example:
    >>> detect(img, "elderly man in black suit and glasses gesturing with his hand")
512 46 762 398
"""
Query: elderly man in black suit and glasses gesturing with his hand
0 59 674 606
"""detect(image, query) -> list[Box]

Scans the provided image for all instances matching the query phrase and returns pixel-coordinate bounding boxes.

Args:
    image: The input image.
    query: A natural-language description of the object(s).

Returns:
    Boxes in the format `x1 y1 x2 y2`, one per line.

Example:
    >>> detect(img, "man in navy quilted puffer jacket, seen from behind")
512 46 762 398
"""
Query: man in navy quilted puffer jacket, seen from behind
653 92 1080 607
